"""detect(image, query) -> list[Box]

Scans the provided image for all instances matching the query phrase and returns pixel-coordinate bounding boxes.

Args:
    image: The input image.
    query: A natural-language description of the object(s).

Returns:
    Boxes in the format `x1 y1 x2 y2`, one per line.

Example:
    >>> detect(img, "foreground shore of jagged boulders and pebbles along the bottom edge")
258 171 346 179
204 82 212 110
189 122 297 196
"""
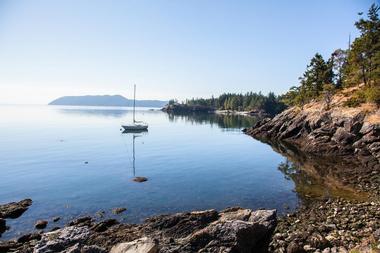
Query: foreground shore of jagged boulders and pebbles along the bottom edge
0 198 380 253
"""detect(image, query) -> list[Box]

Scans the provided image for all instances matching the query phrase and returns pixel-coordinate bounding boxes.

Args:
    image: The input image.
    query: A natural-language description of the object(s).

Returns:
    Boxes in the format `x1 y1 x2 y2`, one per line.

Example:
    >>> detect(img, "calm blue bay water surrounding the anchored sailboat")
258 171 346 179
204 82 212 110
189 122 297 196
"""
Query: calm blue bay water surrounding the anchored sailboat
0 106 298 239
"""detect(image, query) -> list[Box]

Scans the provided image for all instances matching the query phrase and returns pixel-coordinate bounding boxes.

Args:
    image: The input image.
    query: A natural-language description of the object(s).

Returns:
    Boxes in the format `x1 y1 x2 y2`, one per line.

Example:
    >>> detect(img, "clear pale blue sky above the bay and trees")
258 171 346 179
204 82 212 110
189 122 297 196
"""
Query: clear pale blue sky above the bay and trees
0 0 379 104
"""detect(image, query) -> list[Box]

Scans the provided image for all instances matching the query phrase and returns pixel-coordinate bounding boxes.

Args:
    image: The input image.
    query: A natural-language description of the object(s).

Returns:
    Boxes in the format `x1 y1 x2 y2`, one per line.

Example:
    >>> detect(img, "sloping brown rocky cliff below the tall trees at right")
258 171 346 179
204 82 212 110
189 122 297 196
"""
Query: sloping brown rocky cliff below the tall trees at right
246 92 380 170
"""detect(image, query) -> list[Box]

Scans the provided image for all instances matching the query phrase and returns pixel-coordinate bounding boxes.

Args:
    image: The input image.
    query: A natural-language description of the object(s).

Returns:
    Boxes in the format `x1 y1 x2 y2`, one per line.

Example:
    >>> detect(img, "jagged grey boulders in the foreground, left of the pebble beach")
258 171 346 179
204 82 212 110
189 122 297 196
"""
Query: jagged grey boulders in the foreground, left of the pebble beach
0 204 277 253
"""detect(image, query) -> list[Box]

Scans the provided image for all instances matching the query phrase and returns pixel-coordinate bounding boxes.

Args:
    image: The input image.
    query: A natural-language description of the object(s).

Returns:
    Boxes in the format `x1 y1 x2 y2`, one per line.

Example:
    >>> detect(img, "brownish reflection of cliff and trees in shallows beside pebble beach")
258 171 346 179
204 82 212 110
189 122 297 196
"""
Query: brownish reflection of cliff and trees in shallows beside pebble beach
270 139 368 200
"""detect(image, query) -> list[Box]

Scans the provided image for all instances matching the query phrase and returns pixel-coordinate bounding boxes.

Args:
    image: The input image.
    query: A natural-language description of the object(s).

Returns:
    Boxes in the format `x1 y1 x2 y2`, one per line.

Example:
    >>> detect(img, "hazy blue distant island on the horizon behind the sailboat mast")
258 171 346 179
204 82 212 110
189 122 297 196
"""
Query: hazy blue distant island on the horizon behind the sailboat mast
49 95 168 107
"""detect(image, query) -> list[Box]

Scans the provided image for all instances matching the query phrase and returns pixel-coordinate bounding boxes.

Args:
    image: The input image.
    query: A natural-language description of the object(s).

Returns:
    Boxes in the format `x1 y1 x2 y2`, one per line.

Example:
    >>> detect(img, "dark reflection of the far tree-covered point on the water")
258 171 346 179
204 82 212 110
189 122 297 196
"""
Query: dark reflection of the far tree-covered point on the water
168 113 257 130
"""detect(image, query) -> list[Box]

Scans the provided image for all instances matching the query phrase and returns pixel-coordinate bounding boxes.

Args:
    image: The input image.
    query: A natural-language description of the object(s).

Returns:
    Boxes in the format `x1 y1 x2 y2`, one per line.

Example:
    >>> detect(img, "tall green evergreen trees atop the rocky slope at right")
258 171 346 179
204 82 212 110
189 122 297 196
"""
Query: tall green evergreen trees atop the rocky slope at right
282 4 380 108
